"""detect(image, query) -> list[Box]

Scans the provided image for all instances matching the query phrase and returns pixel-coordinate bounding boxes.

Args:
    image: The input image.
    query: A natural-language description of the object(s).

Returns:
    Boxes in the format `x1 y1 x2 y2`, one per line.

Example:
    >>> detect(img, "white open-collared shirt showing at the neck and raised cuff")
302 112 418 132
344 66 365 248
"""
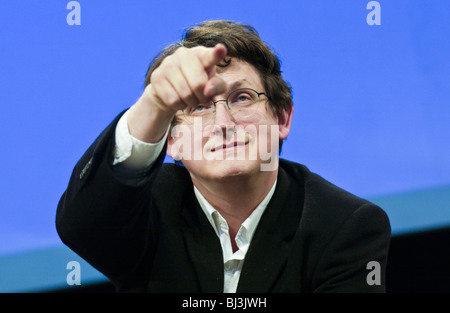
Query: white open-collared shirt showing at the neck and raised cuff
113 111 277 293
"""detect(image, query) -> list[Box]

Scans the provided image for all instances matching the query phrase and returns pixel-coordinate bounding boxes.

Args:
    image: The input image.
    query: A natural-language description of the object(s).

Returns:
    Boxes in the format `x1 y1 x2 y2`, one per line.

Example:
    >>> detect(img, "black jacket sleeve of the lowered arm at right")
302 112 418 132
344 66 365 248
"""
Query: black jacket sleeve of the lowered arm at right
313 203 391 293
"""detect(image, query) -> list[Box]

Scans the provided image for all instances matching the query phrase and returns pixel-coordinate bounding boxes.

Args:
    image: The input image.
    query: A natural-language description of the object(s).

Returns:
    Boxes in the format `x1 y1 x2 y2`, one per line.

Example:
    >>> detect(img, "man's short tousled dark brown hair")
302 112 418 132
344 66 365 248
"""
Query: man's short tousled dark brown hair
145 20 292 150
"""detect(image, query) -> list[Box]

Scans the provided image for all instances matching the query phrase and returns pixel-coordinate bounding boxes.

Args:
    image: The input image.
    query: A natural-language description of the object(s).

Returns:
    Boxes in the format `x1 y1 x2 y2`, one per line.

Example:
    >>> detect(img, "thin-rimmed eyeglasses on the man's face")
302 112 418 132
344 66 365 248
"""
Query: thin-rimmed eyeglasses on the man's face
183 88 270 124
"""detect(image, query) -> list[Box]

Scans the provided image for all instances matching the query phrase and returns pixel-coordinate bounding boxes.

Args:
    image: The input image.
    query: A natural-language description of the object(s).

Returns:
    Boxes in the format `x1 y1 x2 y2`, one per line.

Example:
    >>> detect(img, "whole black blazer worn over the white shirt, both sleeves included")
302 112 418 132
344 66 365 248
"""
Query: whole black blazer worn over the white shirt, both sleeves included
56 115 390 292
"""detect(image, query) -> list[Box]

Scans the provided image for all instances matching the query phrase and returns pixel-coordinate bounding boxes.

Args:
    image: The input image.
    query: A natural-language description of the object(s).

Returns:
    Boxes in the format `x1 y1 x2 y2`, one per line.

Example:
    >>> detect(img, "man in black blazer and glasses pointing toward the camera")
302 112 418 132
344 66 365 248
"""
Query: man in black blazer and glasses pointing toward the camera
56 21 390 292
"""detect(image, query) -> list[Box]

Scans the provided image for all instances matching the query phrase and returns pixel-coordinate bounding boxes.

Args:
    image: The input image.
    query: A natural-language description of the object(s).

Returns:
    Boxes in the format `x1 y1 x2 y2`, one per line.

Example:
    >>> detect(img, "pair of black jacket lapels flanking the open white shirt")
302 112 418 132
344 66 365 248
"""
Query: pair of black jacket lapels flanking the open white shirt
178 167 304 293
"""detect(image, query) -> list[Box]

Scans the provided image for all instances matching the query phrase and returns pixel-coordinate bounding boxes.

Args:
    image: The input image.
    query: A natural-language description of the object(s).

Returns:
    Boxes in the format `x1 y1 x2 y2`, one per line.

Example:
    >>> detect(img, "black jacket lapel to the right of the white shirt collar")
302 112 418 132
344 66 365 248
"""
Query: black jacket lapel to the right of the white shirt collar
237 167 304 293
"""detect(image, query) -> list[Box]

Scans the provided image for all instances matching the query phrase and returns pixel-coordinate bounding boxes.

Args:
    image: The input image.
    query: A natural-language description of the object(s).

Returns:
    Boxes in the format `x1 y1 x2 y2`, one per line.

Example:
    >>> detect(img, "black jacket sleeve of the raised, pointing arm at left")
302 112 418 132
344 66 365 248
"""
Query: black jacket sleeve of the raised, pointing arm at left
56 112 165 289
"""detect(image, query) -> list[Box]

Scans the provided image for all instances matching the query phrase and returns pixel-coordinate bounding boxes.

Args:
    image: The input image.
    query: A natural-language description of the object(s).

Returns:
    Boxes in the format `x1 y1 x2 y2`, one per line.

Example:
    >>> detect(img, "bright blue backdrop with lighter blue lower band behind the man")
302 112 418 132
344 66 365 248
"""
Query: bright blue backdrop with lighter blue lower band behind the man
0 0 450 292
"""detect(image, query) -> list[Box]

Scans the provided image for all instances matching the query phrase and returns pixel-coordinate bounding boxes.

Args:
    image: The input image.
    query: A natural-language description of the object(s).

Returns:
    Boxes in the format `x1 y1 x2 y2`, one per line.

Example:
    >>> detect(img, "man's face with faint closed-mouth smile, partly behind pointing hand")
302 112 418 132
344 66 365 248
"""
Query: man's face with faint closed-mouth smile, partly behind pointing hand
167 59 292 182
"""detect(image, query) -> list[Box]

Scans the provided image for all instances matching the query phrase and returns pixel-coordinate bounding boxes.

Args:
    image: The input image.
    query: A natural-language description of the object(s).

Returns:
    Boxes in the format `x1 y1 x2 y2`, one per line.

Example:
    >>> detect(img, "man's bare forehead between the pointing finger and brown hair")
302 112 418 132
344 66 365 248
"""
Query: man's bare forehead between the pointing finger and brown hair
216 58 262 91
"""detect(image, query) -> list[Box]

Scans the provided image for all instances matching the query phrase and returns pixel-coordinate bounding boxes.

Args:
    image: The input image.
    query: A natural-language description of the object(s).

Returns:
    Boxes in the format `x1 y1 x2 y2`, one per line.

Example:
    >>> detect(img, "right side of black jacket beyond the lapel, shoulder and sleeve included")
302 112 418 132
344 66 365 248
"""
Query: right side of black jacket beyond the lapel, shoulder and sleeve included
280 161 390 292
